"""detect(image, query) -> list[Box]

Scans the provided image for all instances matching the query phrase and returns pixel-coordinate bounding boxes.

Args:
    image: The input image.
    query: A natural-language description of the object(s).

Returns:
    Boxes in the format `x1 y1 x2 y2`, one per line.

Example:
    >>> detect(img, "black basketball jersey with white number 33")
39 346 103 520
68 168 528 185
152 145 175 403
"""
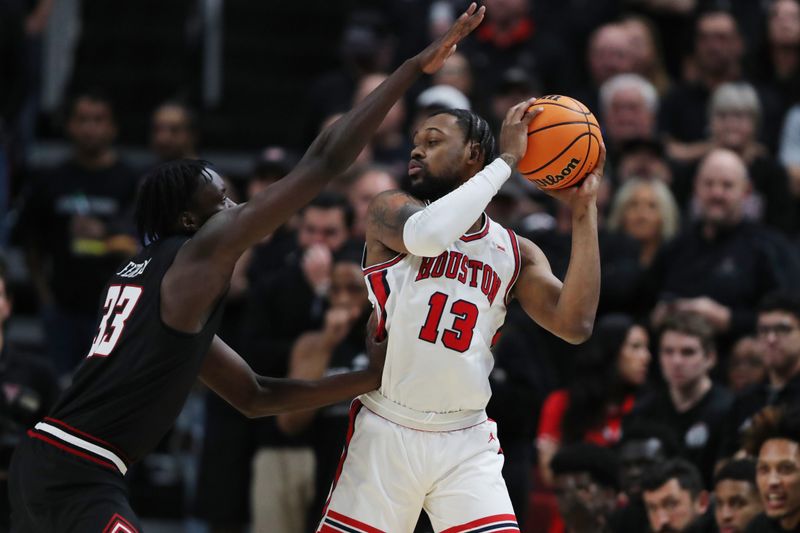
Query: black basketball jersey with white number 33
29 237 222 474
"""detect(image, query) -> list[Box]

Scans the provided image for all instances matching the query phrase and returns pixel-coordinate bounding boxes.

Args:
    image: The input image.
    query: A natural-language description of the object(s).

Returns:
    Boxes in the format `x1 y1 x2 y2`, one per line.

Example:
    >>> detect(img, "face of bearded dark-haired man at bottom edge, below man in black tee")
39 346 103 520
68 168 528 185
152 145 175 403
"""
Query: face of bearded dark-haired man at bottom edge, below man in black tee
644 478 708 533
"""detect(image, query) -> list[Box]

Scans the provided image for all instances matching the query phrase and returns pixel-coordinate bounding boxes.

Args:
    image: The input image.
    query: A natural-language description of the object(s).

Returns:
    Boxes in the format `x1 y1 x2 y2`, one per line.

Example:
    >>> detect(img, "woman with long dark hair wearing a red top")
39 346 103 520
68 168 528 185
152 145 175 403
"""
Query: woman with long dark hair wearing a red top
536 315 650 483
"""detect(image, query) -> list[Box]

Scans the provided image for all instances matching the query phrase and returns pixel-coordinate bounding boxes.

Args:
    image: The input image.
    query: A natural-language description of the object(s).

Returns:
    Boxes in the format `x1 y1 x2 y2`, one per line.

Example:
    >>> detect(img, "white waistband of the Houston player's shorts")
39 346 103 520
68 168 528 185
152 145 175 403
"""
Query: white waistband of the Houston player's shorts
358 391 488 431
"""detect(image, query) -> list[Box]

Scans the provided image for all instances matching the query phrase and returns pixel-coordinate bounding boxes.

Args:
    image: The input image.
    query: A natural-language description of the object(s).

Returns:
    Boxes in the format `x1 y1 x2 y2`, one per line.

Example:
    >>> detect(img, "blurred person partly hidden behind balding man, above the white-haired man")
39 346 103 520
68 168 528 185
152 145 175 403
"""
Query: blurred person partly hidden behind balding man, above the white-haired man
621 14 670 96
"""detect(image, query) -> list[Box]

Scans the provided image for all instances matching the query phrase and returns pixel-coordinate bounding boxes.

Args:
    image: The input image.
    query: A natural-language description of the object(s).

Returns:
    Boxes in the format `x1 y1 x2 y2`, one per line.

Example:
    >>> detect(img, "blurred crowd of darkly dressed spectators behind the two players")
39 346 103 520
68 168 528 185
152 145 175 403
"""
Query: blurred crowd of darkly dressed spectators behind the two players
0 0 800 533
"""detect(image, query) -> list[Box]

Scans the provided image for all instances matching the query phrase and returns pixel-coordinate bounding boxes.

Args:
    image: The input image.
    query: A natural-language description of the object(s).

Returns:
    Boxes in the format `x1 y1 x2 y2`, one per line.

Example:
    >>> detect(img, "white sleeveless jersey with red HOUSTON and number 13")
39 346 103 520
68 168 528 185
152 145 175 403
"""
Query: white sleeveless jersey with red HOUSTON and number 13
361 215 520 431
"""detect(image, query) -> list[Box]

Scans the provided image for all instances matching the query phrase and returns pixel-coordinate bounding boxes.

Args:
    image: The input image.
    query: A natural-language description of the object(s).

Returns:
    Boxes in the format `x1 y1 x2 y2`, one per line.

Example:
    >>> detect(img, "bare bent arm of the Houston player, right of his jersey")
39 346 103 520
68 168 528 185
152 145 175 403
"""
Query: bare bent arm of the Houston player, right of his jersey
514 147 606 344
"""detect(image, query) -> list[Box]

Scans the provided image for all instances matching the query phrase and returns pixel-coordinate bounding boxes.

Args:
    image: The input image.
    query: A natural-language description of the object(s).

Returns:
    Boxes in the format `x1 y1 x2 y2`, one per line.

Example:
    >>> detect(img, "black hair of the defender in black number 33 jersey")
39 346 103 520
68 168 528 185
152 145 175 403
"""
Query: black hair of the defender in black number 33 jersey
135 159 212 244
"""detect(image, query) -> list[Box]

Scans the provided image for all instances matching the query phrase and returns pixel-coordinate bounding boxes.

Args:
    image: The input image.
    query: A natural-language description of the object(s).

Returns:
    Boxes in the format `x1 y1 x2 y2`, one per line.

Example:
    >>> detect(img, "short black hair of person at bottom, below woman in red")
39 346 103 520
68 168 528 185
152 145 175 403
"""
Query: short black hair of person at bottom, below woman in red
550 442 620 490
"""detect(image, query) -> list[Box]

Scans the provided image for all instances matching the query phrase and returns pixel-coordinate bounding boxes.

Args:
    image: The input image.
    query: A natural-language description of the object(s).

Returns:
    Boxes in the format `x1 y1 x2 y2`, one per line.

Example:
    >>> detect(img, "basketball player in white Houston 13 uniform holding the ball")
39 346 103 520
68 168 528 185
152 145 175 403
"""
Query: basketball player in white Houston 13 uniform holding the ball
318 100 605 533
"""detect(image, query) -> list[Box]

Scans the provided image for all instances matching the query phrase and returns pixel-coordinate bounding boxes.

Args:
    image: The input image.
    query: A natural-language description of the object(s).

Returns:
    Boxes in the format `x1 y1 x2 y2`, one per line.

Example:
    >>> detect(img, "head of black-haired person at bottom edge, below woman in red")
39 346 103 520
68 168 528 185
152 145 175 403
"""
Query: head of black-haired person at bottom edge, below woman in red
552 443 619 533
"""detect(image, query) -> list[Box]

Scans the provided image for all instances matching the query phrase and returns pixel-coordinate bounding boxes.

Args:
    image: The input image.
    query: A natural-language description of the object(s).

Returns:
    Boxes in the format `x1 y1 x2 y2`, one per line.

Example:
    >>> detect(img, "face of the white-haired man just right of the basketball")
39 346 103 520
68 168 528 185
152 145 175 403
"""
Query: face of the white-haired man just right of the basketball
605 87 655 143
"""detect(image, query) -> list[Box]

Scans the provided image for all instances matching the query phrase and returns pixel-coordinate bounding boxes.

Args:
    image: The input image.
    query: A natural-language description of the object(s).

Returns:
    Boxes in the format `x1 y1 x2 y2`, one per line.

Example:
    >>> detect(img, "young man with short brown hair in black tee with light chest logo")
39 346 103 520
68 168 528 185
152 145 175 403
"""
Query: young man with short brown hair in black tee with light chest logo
630 314 733 486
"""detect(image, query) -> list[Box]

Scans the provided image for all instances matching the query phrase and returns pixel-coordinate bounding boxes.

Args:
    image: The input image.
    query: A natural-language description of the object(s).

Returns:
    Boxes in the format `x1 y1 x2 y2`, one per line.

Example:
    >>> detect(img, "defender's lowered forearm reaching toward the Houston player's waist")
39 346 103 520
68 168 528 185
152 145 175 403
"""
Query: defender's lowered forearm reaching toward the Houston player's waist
247 370 381 418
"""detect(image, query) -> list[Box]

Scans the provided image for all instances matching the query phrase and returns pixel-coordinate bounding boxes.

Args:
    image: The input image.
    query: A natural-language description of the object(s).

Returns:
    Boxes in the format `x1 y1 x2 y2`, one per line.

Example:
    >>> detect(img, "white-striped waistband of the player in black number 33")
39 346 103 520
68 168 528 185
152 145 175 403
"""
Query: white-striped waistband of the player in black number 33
28 418 128 476
